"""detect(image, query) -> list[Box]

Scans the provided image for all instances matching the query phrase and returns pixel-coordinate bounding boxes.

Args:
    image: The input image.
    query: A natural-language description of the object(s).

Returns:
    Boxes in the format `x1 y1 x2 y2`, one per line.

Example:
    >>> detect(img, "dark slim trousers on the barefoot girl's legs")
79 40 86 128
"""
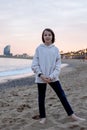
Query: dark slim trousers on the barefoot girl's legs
37 81 74 118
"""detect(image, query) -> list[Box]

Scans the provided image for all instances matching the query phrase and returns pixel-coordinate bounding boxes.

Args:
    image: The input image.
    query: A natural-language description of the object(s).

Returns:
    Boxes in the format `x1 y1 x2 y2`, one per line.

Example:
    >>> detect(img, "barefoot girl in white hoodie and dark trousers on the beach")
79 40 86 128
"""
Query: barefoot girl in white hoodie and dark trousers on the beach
31 28 85 124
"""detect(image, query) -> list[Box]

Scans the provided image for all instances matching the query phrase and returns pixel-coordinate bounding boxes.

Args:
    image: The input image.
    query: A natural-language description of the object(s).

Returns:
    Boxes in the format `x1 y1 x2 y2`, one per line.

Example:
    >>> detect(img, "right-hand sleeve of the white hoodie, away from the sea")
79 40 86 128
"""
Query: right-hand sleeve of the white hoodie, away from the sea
50 50 61 79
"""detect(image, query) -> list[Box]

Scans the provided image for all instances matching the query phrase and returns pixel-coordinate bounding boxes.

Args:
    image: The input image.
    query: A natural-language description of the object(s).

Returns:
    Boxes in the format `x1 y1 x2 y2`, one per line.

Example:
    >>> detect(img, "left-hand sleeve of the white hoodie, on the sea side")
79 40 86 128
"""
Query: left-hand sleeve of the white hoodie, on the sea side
31 49 41 75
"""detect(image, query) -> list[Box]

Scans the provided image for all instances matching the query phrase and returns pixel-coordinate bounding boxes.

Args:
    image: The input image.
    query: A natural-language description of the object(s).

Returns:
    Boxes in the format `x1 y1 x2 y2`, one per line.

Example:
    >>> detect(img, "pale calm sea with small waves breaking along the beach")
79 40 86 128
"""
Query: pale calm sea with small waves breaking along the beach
0 58 67 83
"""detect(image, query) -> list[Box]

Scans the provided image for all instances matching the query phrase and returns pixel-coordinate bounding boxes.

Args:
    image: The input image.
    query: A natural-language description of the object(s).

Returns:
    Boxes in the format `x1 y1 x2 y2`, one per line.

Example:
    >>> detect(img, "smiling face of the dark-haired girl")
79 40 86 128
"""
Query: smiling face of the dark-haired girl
43 31 52 45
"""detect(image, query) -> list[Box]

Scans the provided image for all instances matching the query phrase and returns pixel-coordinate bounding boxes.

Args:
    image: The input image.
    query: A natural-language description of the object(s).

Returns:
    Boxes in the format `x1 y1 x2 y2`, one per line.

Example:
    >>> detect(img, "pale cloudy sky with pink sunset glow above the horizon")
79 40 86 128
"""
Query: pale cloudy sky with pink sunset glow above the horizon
0 0 87 55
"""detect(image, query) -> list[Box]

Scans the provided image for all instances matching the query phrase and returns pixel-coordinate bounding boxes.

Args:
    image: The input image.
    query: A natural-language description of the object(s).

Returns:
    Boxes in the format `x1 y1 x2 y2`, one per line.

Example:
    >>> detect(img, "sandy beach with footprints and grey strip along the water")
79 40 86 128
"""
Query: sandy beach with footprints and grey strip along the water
0 59 87 130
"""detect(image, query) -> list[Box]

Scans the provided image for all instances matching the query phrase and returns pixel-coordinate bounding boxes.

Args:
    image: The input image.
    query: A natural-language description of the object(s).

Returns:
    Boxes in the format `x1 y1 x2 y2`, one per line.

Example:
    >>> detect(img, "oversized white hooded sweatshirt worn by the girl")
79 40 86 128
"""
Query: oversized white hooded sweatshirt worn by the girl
31 43 61 83
